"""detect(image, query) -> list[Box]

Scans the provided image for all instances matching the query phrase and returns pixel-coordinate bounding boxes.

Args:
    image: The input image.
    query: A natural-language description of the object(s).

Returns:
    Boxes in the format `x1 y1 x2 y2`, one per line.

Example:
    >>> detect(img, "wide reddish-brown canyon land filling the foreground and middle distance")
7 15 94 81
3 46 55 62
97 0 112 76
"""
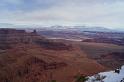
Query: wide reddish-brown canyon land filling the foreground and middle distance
0 29 124 82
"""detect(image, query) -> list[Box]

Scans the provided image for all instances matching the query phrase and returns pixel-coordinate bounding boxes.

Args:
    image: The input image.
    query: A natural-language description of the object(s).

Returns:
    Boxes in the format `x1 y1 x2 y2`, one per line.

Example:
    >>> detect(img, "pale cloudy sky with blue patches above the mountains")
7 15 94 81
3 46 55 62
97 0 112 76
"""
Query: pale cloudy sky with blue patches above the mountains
0 0 124 29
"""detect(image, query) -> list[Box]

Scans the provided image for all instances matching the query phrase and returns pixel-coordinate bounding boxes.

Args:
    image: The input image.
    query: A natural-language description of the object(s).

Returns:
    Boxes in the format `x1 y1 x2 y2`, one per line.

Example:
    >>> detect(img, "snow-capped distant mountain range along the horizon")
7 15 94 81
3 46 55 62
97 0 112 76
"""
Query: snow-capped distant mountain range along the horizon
0 23 124 32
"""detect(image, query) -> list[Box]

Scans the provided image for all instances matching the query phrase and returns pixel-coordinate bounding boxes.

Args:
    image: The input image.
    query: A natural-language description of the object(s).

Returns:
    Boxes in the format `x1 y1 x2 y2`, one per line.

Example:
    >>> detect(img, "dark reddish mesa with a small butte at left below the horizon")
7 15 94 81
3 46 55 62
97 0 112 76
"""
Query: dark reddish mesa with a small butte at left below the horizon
0 29 43 49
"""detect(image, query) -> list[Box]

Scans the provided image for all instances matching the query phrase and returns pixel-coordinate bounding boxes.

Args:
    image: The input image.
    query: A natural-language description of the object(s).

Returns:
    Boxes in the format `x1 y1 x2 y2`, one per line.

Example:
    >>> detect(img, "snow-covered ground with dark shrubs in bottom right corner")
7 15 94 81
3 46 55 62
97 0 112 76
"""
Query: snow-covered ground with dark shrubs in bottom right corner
86 66 124 82
